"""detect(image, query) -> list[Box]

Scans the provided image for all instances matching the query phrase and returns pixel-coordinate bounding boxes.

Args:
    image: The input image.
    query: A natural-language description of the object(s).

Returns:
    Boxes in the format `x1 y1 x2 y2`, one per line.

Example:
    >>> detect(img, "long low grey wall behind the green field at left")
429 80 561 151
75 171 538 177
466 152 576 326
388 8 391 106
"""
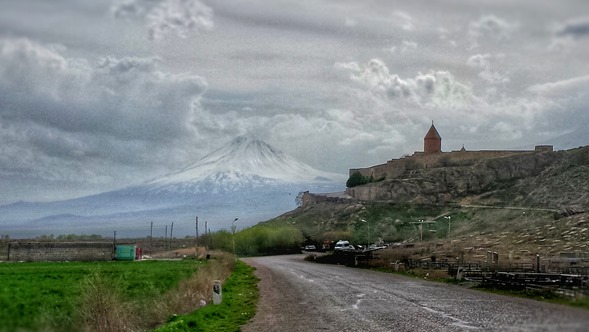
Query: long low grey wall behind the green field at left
7 242 113 262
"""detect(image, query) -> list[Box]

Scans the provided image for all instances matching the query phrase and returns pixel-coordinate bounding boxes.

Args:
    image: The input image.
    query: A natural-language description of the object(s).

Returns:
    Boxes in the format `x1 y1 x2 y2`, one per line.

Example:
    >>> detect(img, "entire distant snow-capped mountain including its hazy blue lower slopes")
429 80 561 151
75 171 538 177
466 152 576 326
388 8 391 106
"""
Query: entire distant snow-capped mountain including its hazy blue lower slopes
0 136 345 237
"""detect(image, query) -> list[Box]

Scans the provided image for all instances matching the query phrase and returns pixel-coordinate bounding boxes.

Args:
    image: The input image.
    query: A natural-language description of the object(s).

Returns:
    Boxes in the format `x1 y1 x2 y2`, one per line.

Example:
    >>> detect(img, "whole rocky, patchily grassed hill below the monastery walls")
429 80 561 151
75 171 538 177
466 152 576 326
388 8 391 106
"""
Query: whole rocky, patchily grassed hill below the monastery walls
268 147 589 261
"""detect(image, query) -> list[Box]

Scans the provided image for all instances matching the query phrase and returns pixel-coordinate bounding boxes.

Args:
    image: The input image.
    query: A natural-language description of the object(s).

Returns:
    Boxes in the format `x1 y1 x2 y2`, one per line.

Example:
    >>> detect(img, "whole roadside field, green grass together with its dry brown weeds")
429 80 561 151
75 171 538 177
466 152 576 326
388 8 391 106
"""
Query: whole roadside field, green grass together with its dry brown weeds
0 253 241 331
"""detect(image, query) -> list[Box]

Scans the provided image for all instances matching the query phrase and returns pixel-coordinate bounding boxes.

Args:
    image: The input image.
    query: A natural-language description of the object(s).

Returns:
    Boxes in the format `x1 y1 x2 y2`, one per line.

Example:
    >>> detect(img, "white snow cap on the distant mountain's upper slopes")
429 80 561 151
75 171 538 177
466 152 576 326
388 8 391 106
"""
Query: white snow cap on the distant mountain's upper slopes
147 136 343 190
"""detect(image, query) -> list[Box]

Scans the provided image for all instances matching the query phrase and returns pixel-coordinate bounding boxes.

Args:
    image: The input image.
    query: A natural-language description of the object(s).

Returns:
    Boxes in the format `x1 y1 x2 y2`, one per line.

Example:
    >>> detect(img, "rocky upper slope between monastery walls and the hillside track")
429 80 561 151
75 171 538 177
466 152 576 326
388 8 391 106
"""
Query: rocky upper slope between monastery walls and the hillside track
348 146 589 212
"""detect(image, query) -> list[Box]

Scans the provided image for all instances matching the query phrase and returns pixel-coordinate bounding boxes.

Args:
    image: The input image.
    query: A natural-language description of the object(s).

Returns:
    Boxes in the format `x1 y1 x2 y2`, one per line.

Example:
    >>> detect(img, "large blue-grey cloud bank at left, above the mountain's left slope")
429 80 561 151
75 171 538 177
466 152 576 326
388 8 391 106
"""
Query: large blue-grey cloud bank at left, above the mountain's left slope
0 39 207 185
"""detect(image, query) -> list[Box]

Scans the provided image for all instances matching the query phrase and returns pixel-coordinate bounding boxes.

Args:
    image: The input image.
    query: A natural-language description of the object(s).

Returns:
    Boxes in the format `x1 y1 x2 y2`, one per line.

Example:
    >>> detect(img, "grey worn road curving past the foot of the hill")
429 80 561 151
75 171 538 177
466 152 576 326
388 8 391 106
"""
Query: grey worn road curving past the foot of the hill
242 255 589 332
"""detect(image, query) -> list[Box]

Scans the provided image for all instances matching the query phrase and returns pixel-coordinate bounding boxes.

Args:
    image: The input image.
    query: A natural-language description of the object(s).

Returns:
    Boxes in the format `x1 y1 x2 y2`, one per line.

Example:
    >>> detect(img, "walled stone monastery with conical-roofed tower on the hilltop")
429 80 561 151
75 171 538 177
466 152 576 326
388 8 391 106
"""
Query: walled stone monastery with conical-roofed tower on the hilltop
349 122 553 181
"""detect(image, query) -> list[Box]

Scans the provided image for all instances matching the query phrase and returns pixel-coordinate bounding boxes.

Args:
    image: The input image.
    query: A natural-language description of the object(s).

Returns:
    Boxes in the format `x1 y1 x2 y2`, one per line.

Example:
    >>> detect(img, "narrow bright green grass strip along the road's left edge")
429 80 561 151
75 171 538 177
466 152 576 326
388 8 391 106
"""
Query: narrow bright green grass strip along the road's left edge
156 261 259 332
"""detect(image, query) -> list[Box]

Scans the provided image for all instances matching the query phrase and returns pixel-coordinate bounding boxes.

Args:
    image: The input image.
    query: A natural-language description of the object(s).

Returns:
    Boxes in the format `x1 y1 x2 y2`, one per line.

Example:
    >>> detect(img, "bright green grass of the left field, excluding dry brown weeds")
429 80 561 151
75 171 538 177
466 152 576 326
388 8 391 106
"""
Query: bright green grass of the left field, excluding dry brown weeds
0 260 198 331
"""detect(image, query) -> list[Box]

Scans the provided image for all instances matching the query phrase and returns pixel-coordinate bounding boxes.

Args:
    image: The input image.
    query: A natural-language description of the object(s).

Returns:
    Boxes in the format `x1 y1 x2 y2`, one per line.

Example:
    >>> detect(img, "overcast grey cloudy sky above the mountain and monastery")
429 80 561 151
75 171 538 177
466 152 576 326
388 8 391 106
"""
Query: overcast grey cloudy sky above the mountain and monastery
0 0 589 203
